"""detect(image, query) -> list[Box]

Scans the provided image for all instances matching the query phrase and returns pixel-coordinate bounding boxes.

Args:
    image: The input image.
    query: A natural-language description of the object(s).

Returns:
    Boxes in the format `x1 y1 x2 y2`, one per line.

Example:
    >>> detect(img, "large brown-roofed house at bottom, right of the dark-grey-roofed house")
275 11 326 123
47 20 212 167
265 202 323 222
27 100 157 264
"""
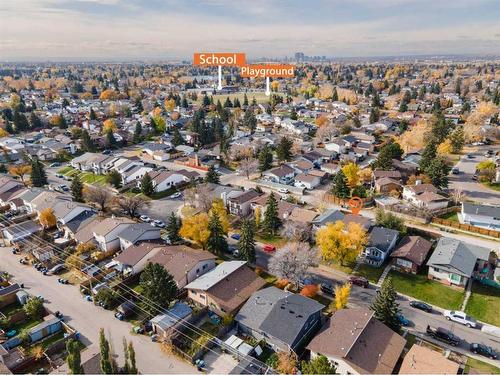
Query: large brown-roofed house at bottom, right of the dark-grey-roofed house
307 308 406 375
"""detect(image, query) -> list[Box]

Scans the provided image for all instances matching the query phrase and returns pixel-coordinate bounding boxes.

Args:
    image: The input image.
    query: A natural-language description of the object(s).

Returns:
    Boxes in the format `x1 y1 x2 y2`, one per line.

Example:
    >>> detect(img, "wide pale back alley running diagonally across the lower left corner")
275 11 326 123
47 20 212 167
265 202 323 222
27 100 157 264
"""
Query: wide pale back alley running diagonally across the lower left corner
0 247 195 374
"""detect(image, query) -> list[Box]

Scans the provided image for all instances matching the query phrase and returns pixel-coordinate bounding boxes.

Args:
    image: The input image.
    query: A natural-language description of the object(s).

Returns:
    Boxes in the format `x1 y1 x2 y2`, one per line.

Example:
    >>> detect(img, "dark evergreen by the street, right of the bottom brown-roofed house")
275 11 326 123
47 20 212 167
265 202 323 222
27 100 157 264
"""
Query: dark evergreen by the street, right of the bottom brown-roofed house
371 276 401 332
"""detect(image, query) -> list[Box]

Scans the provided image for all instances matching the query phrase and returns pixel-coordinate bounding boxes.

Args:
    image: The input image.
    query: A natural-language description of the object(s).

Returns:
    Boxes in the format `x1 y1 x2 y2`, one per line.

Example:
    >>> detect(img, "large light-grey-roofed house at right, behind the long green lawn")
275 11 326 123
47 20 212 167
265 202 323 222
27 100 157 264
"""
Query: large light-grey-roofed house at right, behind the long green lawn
427 237 491 287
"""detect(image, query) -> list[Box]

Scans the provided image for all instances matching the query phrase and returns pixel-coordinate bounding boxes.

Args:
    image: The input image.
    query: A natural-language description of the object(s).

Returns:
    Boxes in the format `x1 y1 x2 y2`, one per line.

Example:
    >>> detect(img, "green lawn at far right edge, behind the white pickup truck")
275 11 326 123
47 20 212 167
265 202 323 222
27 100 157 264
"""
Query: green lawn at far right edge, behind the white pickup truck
465 283 500 326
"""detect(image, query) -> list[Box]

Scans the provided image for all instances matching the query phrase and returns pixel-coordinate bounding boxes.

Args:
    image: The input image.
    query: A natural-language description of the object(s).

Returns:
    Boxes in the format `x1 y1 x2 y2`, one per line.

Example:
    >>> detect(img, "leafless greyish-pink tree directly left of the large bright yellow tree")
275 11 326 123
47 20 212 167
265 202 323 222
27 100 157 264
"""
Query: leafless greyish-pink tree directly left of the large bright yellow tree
269 242 318 286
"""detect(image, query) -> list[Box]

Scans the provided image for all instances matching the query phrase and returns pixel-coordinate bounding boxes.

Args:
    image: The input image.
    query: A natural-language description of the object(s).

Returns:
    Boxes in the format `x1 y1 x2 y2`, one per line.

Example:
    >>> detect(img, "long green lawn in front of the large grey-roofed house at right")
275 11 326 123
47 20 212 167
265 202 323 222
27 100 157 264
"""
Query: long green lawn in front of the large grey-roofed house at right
389 271 464 310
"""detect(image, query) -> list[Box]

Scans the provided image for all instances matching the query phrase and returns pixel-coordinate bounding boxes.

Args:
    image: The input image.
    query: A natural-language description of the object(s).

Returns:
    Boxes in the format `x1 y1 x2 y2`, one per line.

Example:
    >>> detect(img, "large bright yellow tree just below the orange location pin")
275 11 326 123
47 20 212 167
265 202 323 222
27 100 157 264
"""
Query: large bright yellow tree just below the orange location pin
316 220 368 265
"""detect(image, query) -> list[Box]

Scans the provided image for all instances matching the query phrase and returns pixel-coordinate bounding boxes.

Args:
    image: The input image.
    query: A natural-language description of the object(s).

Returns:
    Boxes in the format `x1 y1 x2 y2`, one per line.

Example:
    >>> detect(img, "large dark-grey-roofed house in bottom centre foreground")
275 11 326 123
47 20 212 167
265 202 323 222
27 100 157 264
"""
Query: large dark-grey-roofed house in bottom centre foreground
234 286 324 352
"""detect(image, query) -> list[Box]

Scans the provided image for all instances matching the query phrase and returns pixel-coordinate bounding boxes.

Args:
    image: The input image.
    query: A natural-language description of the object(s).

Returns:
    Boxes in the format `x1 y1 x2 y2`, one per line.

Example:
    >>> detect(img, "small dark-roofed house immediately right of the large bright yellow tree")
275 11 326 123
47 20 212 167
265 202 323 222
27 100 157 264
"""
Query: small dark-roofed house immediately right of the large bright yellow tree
364 227 399 267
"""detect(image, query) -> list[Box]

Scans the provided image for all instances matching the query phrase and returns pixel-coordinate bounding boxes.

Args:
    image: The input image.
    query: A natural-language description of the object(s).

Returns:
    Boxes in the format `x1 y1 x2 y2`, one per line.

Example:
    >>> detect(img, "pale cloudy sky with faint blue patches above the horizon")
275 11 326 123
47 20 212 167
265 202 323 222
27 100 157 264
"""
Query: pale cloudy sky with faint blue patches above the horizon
0 0 500 61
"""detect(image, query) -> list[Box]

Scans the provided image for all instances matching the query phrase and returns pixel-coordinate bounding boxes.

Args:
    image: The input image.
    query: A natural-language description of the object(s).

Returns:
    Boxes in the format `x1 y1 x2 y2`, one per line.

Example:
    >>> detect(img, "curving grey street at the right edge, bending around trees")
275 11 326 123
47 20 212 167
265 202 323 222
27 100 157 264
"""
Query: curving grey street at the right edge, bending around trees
449 146 500 204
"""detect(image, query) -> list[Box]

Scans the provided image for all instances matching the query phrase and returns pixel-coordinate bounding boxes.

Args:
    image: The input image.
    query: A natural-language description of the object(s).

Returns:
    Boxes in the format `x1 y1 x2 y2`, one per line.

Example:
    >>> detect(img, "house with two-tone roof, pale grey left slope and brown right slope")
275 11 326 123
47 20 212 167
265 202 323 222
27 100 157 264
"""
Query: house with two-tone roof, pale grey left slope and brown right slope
184 261 266 316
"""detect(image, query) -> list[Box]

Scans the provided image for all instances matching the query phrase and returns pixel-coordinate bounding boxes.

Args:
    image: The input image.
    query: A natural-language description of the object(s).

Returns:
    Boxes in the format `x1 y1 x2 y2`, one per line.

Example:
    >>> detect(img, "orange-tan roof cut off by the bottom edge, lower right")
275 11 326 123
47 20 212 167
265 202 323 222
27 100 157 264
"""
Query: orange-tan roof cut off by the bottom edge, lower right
399 345 460 375
